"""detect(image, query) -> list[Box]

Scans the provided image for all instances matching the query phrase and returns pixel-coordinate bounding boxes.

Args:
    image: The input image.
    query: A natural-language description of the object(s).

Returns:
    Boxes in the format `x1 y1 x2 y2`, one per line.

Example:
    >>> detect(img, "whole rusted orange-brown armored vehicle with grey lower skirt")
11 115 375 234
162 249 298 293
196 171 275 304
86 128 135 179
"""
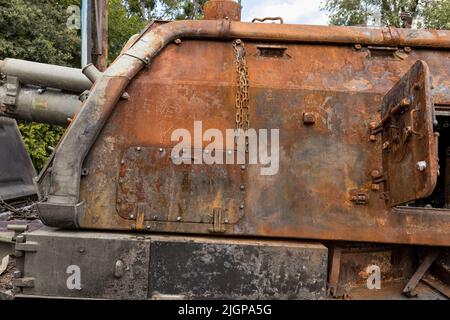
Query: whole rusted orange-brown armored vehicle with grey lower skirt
0 1 450 299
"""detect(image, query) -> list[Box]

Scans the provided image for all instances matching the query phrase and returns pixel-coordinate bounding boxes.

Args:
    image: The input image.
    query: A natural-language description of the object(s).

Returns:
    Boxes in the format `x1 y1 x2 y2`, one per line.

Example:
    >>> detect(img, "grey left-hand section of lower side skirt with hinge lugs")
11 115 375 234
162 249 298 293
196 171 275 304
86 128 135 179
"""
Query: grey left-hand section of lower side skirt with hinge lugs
16 229 150 299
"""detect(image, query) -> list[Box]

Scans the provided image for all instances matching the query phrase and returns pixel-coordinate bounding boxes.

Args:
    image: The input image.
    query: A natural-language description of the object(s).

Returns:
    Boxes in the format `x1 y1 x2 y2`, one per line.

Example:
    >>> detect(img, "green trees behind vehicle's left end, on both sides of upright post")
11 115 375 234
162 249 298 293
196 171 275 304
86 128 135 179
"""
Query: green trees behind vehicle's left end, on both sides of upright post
0 0 206 170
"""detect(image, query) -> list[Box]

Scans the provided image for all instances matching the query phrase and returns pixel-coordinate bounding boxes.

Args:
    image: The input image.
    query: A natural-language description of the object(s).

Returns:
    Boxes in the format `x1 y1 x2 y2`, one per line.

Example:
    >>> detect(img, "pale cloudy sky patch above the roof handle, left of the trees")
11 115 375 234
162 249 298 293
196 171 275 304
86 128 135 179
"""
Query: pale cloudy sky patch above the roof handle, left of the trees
242 0 328 25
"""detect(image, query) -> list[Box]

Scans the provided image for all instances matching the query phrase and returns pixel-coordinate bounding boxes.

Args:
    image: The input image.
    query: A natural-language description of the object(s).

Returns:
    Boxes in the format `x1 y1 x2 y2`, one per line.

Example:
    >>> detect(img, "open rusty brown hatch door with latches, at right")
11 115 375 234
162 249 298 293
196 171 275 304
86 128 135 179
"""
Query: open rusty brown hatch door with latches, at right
380 61 439 206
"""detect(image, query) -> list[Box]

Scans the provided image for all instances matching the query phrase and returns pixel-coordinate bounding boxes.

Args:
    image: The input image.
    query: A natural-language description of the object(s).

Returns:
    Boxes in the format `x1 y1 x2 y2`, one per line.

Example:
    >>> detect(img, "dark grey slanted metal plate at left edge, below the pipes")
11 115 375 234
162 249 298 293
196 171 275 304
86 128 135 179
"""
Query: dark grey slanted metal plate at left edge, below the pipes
0 117 37 201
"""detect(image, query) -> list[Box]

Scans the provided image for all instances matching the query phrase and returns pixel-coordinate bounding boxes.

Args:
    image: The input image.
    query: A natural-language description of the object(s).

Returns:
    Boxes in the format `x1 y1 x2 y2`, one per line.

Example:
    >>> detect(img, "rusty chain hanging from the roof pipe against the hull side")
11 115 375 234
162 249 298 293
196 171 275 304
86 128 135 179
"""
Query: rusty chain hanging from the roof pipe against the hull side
233 39 250 131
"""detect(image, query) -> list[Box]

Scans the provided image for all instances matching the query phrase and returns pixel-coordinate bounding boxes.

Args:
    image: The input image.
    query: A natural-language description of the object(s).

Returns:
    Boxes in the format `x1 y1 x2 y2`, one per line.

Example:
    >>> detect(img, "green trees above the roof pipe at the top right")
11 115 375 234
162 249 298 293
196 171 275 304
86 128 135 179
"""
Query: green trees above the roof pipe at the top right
322 0 450 29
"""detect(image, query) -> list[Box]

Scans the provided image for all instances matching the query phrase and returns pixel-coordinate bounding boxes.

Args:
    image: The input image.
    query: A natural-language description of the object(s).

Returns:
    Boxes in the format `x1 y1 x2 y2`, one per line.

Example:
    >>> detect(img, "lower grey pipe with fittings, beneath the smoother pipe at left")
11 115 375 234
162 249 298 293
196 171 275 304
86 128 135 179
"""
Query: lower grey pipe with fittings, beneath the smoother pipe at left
0 86 82 127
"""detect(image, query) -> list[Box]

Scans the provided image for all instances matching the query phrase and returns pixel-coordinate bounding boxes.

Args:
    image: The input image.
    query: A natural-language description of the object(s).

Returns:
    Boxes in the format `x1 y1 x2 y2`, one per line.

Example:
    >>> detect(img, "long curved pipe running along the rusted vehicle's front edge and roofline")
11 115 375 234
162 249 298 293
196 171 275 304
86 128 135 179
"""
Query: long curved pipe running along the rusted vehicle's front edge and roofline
40 20 450 215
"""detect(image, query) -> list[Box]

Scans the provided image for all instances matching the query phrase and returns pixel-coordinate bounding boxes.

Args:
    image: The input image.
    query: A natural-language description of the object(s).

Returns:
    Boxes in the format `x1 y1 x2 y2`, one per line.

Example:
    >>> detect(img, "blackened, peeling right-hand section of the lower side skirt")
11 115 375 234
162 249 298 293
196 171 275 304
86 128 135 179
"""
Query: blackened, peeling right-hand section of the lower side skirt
149 238 328 300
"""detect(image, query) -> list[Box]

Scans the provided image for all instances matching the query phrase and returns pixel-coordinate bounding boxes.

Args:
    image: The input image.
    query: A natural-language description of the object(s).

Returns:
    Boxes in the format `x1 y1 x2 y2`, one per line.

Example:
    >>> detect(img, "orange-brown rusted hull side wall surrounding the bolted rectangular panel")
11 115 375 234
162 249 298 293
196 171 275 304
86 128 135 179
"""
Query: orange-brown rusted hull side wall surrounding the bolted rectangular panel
74 41 450 245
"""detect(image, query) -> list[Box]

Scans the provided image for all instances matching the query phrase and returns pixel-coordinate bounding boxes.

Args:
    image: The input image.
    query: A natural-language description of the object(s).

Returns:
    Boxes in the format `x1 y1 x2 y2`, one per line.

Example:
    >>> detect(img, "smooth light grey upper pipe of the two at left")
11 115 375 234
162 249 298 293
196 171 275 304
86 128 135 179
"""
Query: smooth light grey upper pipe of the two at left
0 59 92 93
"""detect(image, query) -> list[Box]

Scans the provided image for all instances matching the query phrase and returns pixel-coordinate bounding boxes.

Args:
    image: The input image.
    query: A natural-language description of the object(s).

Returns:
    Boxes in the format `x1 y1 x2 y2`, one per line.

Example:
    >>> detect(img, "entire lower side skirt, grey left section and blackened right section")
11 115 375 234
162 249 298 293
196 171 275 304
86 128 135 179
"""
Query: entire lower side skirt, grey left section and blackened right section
14 228 328 299
